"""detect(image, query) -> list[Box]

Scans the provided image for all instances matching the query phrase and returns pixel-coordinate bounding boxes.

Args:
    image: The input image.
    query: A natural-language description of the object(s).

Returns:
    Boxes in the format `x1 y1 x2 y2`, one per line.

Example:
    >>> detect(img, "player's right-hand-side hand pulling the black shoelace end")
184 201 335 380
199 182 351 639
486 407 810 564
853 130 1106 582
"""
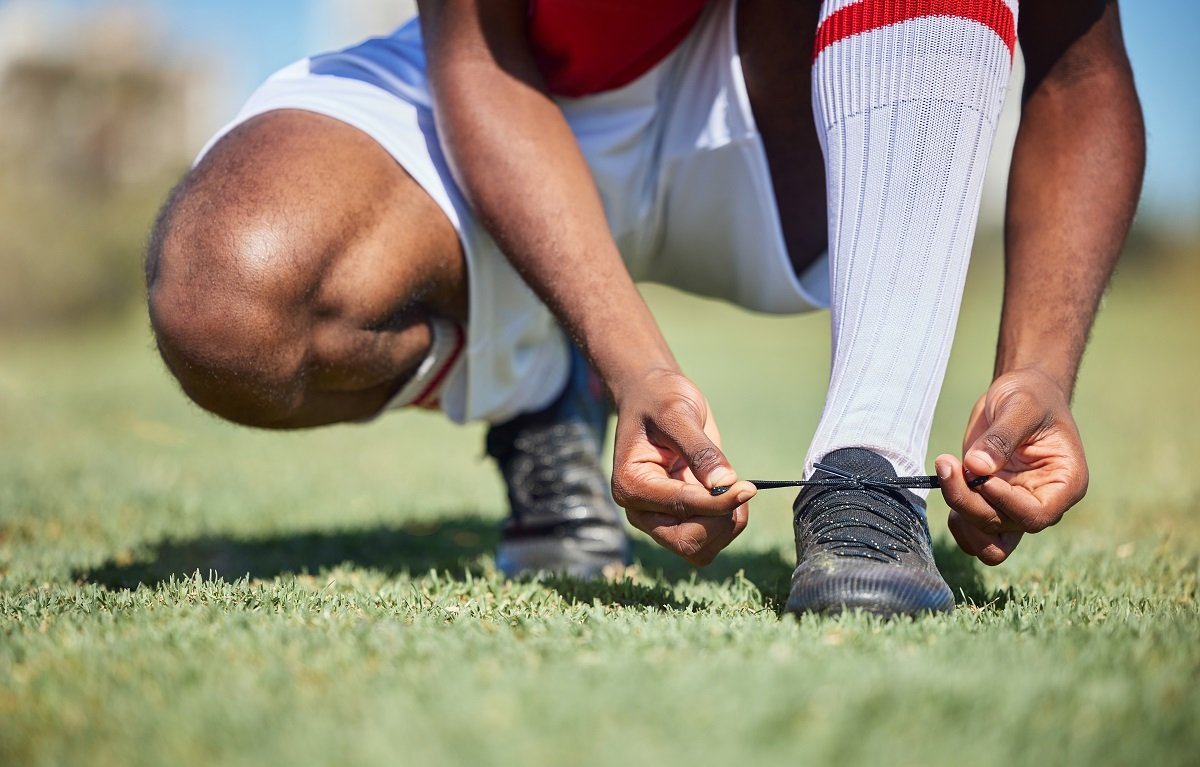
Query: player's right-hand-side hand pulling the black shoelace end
935 370 1087 565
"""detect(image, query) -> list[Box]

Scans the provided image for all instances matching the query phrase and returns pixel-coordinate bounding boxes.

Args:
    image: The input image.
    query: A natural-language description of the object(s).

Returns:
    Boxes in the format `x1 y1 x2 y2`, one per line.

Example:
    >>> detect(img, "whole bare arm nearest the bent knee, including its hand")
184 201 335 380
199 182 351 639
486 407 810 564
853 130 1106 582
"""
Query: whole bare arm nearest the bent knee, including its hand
420 0 754 563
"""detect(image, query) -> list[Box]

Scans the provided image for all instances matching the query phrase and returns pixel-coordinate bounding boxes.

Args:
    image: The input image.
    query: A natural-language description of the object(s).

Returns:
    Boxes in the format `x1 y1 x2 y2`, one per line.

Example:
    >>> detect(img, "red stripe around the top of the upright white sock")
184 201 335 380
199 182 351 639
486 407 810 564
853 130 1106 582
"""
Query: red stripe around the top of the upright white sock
812 0 1016 60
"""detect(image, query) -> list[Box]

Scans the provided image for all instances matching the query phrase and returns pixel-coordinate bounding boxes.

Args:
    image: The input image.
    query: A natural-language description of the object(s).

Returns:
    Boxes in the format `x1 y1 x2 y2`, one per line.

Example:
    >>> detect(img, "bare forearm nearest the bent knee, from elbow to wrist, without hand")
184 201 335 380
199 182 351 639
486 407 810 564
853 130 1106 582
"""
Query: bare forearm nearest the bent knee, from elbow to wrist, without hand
427 3 678 399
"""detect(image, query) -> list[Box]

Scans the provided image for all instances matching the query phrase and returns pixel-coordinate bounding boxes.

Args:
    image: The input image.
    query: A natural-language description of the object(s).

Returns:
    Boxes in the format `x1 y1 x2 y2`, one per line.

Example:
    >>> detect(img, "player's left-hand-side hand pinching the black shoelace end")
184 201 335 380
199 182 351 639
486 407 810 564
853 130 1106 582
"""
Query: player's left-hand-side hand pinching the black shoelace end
612 371 757 567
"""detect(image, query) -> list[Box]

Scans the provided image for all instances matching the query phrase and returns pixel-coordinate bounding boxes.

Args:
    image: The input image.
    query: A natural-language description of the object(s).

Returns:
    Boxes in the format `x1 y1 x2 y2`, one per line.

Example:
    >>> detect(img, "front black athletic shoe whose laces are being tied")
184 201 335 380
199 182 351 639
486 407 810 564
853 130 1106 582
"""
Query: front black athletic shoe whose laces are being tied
787 448 954 617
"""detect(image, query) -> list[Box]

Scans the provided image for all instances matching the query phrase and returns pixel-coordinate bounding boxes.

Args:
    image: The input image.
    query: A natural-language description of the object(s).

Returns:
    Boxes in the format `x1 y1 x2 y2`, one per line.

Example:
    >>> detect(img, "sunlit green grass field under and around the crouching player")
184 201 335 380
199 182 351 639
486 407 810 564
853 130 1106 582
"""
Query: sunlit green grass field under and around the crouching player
0 249 1200 767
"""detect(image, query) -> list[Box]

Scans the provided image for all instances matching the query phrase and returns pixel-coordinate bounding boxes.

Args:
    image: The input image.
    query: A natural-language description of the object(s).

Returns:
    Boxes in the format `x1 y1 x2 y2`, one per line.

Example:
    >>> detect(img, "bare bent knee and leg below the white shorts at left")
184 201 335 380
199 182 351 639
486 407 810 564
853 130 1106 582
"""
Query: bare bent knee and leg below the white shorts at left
146 110 467 429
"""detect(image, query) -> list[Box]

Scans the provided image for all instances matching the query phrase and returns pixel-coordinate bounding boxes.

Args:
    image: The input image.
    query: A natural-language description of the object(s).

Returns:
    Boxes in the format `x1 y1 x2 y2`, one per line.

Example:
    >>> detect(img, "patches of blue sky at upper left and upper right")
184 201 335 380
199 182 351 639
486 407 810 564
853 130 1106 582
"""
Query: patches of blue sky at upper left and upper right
9 0 1200 222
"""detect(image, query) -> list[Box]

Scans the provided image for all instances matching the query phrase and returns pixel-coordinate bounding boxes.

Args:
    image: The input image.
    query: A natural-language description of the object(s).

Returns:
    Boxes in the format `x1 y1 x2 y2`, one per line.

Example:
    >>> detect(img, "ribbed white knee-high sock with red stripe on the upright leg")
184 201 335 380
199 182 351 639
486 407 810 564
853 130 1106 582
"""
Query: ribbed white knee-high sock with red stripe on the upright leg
806 0 1016 474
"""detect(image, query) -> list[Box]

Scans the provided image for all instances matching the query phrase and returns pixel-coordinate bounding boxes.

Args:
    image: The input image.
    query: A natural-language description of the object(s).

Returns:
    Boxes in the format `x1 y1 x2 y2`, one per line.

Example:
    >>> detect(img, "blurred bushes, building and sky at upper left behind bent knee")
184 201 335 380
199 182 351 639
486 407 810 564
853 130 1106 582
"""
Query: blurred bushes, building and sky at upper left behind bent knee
0 0 414 332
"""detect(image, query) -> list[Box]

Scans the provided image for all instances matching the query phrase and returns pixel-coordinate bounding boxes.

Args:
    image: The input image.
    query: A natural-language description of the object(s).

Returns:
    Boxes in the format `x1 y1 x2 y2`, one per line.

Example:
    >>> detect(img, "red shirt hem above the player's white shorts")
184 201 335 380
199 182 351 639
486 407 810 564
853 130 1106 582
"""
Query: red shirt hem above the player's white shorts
529 0 707 96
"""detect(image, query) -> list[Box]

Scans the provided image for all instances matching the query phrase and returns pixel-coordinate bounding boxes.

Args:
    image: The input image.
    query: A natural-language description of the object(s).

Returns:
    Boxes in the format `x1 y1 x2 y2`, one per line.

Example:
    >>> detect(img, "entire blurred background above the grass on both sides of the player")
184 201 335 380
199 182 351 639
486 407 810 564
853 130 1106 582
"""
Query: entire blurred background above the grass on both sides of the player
0 0 1200 332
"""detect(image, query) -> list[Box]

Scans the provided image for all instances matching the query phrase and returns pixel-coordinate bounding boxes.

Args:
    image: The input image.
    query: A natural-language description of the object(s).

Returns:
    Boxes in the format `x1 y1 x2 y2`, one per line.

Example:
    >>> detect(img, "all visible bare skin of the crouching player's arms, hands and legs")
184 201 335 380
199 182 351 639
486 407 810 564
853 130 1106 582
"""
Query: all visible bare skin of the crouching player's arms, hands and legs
149 0 1144 565
